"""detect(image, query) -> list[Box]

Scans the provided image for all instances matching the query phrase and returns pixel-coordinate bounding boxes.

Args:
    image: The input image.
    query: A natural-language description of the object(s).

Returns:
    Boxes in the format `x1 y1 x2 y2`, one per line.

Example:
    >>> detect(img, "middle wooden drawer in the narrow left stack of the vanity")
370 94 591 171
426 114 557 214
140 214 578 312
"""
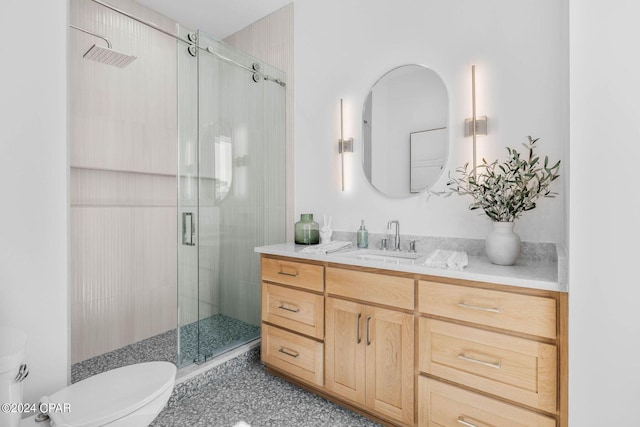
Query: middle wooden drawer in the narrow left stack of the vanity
262 282 324 339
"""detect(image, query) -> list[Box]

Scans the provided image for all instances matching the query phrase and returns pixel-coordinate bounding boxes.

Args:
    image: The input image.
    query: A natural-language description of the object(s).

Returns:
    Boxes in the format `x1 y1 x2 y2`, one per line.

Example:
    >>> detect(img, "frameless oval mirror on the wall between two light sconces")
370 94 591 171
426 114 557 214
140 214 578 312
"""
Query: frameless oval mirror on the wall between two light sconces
362 65 449 197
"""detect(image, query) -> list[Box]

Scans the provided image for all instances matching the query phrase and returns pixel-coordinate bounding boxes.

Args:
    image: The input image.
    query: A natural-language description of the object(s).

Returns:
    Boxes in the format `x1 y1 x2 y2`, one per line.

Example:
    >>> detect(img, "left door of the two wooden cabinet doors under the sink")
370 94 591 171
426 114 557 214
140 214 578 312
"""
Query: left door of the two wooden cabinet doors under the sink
325 298 365 405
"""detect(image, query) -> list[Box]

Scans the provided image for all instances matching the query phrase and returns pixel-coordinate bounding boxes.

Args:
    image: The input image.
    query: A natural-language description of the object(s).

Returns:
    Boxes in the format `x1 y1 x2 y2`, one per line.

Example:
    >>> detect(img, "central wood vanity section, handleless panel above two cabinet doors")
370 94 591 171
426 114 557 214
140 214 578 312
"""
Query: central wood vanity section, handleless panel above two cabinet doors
325 267 415 425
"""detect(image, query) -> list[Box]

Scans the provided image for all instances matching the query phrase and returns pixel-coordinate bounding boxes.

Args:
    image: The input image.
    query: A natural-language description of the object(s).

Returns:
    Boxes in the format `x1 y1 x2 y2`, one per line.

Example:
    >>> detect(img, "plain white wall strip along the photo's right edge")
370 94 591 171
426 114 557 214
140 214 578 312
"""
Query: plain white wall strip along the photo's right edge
569 0 640 427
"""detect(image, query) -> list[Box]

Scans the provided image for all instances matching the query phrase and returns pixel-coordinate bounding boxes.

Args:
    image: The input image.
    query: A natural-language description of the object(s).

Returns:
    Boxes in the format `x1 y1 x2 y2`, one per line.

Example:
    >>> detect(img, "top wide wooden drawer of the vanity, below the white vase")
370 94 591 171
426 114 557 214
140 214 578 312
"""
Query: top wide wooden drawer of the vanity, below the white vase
418 280 557 339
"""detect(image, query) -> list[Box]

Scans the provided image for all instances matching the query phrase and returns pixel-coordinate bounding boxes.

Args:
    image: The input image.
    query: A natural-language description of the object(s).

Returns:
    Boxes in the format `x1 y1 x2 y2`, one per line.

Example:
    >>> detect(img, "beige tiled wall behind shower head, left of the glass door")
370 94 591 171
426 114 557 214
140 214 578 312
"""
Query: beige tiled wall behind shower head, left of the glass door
69 0 177 363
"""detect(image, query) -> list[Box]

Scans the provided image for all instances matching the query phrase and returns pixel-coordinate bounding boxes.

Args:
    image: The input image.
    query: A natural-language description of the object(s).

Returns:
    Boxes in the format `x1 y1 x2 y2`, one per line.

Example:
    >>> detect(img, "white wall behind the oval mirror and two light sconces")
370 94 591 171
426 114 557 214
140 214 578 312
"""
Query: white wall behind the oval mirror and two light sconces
294 0 568 242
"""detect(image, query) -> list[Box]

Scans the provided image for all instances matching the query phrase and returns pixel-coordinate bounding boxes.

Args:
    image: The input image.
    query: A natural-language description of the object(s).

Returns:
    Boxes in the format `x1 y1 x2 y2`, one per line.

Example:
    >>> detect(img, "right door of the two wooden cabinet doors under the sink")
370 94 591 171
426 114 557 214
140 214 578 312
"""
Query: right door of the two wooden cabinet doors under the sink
363 306 414 424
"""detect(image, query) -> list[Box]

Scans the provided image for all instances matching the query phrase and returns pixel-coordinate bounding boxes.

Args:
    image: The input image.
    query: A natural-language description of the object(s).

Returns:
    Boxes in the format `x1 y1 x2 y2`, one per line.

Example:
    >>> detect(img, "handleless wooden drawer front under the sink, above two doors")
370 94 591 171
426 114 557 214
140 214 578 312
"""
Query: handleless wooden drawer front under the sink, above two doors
326 267 415 310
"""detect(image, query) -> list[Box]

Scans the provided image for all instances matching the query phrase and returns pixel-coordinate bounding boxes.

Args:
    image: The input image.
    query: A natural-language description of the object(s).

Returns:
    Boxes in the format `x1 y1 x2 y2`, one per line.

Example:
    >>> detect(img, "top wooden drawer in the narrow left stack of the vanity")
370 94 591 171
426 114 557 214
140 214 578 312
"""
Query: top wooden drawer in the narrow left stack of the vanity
262 257 324 292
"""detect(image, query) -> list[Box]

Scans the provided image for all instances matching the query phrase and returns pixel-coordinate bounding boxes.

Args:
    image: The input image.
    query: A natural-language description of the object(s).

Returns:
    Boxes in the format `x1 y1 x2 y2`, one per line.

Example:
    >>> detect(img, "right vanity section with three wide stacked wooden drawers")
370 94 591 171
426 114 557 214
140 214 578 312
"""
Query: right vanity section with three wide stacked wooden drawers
418 280 567 426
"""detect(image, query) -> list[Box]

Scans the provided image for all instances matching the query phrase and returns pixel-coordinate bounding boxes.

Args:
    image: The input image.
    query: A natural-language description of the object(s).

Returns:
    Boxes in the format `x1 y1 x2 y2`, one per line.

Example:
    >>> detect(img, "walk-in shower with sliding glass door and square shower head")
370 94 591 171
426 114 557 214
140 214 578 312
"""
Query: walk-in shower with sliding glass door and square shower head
69 0 286 382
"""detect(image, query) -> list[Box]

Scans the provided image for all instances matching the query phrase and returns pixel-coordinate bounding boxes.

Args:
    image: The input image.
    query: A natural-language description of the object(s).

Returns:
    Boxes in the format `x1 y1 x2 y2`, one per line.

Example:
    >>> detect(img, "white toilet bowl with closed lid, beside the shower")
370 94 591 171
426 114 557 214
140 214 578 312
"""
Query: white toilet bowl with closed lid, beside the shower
40 362 176 427
